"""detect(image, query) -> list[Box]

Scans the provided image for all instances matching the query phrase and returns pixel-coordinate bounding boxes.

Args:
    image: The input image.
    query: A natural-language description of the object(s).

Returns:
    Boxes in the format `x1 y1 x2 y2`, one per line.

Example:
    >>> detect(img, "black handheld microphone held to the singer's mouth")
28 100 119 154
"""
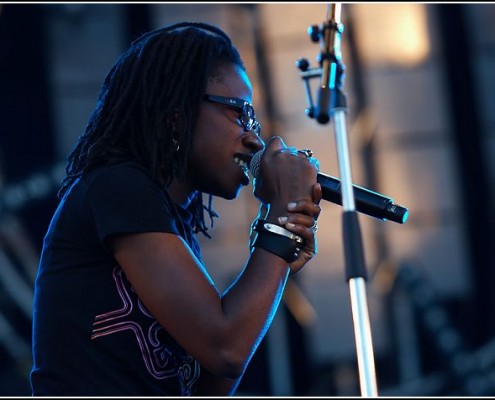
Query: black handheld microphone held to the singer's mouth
249 150 409 224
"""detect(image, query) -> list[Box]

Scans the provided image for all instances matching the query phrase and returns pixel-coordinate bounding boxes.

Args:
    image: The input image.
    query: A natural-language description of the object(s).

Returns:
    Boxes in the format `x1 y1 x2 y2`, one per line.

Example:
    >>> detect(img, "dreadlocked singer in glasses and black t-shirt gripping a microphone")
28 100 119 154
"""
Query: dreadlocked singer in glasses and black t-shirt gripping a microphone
30 23 322 396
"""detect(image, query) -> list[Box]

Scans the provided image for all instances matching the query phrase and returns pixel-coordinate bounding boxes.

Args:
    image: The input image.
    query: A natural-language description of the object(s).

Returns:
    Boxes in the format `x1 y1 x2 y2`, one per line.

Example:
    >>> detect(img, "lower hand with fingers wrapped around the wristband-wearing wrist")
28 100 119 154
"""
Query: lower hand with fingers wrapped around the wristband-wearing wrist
279 183 322 276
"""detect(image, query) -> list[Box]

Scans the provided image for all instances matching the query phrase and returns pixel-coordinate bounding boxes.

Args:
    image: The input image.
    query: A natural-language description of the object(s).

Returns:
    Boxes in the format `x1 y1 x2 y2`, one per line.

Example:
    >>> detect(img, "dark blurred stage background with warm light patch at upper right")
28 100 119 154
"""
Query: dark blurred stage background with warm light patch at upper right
0 3 495 396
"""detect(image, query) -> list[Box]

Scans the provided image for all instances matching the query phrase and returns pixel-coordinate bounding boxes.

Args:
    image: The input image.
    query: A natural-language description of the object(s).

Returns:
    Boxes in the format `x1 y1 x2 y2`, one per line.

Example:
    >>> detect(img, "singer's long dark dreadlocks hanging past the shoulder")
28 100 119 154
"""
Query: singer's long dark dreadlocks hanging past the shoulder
58 22 245 237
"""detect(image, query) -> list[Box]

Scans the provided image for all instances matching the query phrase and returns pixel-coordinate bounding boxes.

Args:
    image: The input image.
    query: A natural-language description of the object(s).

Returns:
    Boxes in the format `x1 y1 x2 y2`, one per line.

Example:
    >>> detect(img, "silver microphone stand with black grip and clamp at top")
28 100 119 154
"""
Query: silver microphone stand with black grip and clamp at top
296 3 377 397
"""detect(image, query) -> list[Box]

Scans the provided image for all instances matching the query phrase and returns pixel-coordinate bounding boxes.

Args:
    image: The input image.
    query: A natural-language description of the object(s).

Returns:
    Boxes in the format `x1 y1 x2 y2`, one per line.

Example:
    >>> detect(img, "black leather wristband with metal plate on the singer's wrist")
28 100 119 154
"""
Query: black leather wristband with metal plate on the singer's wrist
253 220 303 263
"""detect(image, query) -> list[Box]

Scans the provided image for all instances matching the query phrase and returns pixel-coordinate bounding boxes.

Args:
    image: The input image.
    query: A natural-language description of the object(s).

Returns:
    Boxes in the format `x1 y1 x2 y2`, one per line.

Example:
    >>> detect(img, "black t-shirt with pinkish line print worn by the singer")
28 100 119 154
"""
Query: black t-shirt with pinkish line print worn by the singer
31 162 201 396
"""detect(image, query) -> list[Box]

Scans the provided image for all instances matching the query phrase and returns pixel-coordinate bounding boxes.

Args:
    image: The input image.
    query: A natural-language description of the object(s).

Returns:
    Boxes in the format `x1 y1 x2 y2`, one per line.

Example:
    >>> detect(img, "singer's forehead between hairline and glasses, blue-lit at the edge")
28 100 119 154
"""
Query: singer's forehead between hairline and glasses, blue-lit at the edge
206 65 253 102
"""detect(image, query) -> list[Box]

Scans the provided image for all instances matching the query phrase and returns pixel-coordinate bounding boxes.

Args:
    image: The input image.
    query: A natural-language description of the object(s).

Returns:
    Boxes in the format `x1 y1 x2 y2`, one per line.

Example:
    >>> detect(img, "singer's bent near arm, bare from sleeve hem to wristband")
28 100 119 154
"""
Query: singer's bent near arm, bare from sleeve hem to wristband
106 225 289 378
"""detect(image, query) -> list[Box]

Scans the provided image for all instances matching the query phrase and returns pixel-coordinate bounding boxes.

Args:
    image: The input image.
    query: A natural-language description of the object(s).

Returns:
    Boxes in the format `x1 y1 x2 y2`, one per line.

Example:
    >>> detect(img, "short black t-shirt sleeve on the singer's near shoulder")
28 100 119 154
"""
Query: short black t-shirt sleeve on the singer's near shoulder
86 164 179 243
